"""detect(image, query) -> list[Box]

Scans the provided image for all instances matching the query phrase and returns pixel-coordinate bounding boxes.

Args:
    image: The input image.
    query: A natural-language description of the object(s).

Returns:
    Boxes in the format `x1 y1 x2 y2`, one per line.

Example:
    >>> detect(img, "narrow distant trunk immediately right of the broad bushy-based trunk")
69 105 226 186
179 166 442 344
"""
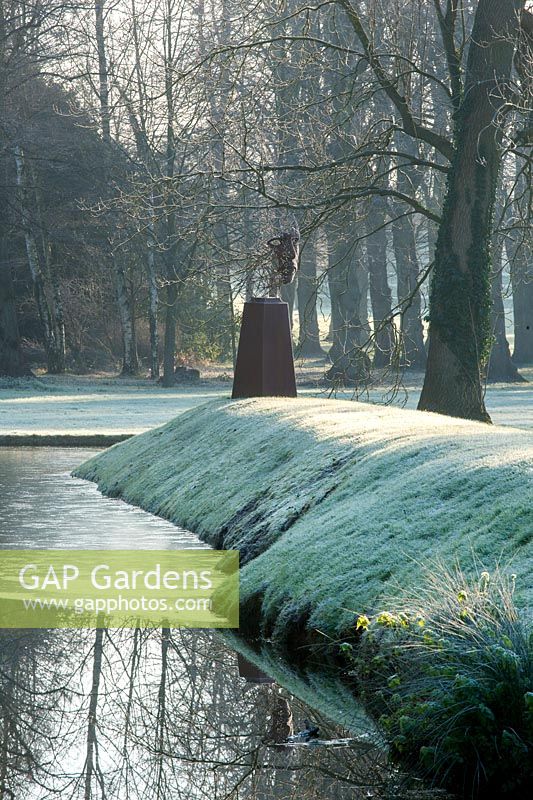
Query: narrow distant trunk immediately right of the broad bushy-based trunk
366 198 393 367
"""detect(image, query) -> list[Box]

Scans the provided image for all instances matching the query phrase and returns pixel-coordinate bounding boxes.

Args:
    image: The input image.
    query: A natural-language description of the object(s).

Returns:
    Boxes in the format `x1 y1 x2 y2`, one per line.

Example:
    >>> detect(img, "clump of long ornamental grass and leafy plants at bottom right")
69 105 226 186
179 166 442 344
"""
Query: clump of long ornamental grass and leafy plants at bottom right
341 568 533 800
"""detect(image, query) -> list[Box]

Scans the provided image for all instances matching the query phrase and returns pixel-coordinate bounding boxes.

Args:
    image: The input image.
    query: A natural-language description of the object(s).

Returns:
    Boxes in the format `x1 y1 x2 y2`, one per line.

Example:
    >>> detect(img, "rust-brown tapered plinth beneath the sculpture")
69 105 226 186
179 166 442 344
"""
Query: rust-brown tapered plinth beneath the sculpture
231 297 296 399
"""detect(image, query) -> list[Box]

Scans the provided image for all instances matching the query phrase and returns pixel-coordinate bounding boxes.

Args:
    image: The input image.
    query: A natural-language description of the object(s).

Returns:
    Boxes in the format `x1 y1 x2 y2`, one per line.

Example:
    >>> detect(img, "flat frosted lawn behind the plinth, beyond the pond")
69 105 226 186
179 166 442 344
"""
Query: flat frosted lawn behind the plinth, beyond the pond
0 361 533 436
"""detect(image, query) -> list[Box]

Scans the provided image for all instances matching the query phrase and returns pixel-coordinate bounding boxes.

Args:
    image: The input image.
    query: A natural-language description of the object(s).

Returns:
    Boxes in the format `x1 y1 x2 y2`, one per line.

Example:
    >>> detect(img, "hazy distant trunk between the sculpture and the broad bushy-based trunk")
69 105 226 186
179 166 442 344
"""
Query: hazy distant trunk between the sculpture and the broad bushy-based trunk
297 231 324 358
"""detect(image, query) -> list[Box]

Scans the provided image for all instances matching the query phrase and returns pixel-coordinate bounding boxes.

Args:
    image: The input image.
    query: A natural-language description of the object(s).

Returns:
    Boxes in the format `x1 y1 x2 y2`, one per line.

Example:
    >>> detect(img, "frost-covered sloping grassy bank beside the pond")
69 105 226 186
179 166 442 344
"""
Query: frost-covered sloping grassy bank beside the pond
77 399 533 644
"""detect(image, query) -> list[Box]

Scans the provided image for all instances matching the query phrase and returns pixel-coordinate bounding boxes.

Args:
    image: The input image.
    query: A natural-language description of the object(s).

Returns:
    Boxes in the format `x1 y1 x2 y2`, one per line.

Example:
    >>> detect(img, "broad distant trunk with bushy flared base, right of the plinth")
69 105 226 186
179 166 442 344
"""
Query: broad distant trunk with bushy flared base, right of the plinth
326 231 370 384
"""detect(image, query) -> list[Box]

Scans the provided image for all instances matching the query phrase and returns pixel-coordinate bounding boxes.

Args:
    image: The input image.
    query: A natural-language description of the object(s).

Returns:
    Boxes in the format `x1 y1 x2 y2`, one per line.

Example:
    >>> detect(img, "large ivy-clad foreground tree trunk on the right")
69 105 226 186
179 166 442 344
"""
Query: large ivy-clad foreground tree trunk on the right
418 0 523 422
